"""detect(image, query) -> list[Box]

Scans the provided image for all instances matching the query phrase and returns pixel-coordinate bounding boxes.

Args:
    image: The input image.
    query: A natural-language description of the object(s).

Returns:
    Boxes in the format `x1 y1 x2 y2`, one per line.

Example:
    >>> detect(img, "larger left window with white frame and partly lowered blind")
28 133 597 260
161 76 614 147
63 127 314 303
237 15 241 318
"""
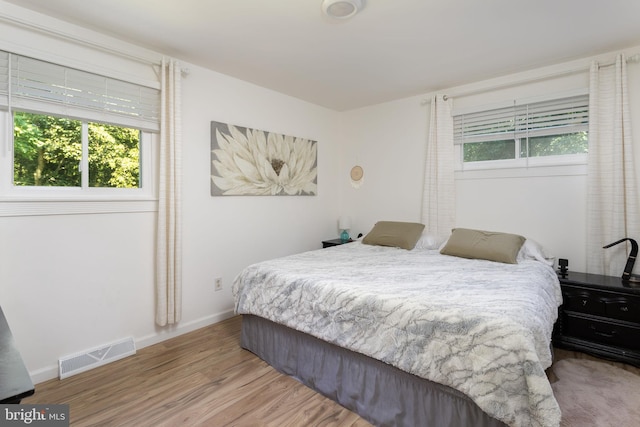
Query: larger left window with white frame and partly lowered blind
0 51 160 208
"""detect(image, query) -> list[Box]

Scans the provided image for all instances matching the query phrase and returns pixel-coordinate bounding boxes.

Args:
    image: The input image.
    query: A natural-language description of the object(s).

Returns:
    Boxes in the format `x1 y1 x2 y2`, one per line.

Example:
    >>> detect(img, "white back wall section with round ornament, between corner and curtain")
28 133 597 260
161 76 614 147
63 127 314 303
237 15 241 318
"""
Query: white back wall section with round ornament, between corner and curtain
340 96 429 235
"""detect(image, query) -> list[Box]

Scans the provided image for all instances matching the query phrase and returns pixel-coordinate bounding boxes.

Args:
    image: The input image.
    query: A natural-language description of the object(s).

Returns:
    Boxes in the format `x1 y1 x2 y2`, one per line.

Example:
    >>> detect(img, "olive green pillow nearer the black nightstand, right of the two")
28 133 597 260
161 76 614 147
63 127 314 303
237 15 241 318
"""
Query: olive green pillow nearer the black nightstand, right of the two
440 228 525 264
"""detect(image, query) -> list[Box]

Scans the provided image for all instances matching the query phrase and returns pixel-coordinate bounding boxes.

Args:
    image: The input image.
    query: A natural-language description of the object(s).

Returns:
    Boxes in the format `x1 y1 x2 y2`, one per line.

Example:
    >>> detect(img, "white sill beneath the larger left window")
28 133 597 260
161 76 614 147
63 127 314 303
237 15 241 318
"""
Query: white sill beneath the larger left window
0 199 158 217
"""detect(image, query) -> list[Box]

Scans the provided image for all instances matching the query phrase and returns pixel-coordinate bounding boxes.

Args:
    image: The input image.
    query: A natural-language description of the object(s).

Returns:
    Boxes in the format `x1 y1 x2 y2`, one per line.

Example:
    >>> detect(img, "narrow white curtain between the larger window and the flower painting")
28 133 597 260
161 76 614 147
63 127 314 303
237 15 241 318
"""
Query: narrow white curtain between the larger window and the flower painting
156 59 182 326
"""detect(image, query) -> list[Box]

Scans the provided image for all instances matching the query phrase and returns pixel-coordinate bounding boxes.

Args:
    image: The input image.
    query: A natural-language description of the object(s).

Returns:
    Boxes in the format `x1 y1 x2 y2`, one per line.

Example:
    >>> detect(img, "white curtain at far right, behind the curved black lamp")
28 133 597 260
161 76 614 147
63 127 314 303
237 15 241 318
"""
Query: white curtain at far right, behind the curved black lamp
587 55 640 276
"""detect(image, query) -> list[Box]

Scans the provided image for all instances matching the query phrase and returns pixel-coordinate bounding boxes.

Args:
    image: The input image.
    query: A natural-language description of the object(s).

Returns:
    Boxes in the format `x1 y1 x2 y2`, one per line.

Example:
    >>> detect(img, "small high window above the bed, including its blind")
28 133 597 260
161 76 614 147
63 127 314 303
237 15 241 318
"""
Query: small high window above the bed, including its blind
454 95 589 169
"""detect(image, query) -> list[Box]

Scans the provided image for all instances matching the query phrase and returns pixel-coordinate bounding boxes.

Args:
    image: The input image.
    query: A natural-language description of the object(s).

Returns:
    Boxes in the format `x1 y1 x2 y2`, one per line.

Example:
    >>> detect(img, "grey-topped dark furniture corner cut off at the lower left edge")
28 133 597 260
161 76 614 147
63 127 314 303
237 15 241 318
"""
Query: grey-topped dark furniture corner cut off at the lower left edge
0 308 35 404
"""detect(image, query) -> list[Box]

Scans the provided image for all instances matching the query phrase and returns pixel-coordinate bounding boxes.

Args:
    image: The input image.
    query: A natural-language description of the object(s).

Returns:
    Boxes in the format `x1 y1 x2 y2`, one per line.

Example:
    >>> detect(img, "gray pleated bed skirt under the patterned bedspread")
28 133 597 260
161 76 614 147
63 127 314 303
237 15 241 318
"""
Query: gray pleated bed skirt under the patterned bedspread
241 315 505 427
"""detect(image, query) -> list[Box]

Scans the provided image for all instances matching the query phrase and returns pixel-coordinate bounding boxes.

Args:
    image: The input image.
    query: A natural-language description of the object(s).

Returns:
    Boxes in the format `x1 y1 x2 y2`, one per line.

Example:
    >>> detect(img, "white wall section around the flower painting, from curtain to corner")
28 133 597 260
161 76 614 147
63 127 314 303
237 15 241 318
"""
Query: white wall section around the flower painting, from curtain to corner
183 60 340 332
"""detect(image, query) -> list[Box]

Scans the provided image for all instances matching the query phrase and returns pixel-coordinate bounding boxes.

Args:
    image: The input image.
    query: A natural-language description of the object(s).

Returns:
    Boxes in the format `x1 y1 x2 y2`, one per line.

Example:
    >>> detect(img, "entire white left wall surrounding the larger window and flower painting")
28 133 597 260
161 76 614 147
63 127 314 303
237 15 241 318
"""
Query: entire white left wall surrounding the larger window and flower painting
0 0 340 382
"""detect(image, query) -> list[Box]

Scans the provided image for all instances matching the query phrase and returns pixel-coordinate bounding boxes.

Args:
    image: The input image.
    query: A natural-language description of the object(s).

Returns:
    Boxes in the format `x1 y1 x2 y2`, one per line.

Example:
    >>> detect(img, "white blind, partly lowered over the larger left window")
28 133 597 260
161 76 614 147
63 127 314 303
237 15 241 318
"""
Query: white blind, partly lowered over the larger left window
0 52 160 132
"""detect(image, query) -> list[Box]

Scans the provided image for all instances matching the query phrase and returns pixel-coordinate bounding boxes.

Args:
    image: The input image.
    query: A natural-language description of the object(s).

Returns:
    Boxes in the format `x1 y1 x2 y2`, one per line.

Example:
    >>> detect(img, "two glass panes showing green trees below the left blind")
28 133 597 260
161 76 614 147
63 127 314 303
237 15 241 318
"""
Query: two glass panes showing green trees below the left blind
13 112 140 188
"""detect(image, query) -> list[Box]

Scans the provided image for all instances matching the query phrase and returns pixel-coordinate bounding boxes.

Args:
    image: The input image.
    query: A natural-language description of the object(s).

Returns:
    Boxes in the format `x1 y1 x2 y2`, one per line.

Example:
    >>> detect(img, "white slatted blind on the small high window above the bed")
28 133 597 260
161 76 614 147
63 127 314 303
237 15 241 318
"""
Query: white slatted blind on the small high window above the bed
453 95 589 144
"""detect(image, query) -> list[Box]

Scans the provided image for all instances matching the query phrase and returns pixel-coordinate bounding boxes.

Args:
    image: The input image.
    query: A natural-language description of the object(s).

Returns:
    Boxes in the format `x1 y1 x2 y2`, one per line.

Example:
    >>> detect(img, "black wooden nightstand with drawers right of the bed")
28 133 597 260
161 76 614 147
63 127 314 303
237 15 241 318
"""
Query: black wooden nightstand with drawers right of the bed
553 271 640 366
